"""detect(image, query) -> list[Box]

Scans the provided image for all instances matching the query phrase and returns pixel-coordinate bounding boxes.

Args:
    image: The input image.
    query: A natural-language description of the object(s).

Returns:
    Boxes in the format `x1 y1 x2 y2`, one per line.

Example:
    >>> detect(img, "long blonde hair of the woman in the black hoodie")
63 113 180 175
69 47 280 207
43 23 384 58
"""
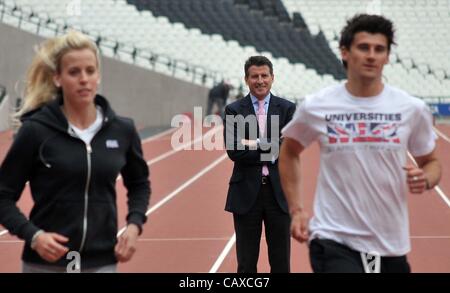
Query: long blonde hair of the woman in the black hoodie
14 31 100 124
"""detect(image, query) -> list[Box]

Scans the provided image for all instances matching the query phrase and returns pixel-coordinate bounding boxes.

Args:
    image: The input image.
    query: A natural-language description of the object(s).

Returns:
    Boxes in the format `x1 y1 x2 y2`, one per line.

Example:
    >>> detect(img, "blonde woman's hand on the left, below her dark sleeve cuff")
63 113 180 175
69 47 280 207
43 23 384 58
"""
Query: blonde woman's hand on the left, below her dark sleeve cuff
33 232 69 262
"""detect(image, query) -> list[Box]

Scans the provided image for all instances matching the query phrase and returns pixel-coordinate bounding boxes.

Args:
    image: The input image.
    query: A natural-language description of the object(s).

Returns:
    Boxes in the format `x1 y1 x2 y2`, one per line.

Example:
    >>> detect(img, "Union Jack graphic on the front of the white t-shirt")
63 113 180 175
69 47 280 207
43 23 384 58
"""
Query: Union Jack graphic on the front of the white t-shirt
327 122 400 144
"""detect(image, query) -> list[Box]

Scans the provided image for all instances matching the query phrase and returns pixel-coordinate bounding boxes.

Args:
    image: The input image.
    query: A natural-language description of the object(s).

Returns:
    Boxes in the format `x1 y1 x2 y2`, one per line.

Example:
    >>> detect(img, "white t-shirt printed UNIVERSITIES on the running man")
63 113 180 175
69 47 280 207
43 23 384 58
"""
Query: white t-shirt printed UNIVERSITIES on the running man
282 84 437 256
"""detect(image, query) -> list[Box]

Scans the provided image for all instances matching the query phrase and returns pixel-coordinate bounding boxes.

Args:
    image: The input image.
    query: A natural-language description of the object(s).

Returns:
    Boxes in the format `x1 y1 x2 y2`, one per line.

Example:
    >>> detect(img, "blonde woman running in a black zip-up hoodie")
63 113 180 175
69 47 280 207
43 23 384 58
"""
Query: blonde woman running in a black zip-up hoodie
0 31 150 272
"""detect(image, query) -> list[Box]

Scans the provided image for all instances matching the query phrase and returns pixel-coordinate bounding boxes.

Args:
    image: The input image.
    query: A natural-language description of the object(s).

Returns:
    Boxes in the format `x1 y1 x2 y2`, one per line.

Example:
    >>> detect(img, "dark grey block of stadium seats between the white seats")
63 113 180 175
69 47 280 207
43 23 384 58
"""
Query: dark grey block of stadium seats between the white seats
127 0 345 79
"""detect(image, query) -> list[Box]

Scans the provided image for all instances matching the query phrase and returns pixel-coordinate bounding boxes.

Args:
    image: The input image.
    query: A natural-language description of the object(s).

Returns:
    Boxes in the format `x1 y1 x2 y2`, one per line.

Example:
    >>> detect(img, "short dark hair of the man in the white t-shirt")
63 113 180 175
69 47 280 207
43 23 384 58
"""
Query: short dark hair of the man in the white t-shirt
339 14 395 68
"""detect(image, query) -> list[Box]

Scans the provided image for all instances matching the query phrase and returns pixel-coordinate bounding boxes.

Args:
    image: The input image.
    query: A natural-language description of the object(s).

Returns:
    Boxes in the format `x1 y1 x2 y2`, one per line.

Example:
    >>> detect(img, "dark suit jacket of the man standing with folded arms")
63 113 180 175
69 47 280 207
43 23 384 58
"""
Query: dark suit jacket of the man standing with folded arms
224 94 295 214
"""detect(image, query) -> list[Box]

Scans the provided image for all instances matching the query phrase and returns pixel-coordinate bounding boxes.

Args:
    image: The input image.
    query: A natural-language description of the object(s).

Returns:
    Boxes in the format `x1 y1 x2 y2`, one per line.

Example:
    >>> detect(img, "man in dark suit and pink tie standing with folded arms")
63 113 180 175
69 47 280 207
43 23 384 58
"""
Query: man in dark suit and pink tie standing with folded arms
224 56 295 273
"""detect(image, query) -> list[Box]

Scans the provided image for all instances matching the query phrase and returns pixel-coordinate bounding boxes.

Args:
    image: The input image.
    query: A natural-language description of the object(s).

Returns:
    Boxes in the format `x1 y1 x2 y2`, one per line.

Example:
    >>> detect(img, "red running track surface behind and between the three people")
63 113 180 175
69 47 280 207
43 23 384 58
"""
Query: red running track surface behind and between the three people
0 125 450 272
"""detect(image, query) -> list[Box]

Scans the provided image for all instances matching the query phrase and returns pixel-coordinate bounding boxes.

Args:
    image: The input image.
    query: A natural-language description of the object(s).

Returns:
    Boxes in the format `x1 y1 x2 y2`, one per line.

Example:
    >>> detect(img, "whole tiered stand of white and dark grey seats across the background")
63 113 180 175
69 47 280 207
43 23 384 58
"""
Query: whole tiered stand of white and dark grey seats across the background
0 0 450 101
